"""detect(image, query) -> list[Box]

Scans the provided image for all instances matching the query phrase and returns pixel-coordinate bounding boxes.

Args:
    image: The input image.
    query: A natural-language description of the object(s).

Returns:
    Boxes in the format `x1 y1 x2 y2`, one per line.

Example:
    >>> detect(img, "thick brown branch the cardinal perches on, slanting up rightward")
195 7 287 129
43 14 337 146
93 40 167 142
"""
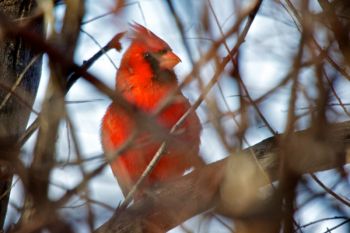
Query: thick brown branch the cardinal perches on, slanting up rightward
95 121 350 233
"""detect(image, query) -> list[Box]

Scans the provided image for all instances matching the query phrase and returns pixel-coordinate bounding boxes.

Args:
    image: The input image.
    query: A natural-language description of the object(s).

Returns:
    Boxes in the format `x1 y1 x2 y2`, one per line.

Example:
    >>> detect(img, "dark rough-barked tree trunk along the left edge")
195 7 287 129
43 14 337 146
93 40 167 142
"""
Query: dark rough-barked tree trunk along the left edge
0 0 43 229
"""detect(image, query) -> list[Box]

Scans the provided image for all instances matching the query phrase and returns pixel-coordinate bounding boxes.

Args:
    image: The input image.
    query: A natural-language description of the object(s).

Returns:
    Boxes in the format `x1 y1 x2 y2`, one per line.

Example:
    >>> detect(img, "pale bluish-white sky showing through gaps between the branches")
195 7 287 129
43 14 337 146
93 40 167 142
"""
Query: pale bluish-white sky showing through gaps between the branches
7 0 350 233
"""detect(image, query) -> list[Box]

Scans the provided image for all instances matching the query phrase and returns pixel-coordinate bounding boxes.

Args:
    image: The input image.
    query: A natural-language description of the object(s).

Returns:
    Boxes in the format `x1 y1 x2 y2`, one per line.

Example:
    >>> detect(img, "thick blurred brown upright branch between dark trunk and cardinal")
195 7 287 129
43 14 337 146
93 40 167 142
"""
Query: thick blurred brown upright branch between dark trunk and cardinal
17 0 84 226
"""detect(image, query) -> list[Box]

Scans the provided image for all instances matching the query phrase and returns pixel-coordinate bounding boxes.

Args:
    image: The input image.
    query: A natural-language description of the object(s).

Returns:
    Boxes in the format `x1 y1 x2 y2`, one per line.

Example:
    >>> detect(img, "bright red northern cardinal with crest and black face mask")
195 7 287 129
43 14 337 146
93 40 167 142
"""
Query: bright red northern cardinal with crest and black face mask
101 23 202 196
